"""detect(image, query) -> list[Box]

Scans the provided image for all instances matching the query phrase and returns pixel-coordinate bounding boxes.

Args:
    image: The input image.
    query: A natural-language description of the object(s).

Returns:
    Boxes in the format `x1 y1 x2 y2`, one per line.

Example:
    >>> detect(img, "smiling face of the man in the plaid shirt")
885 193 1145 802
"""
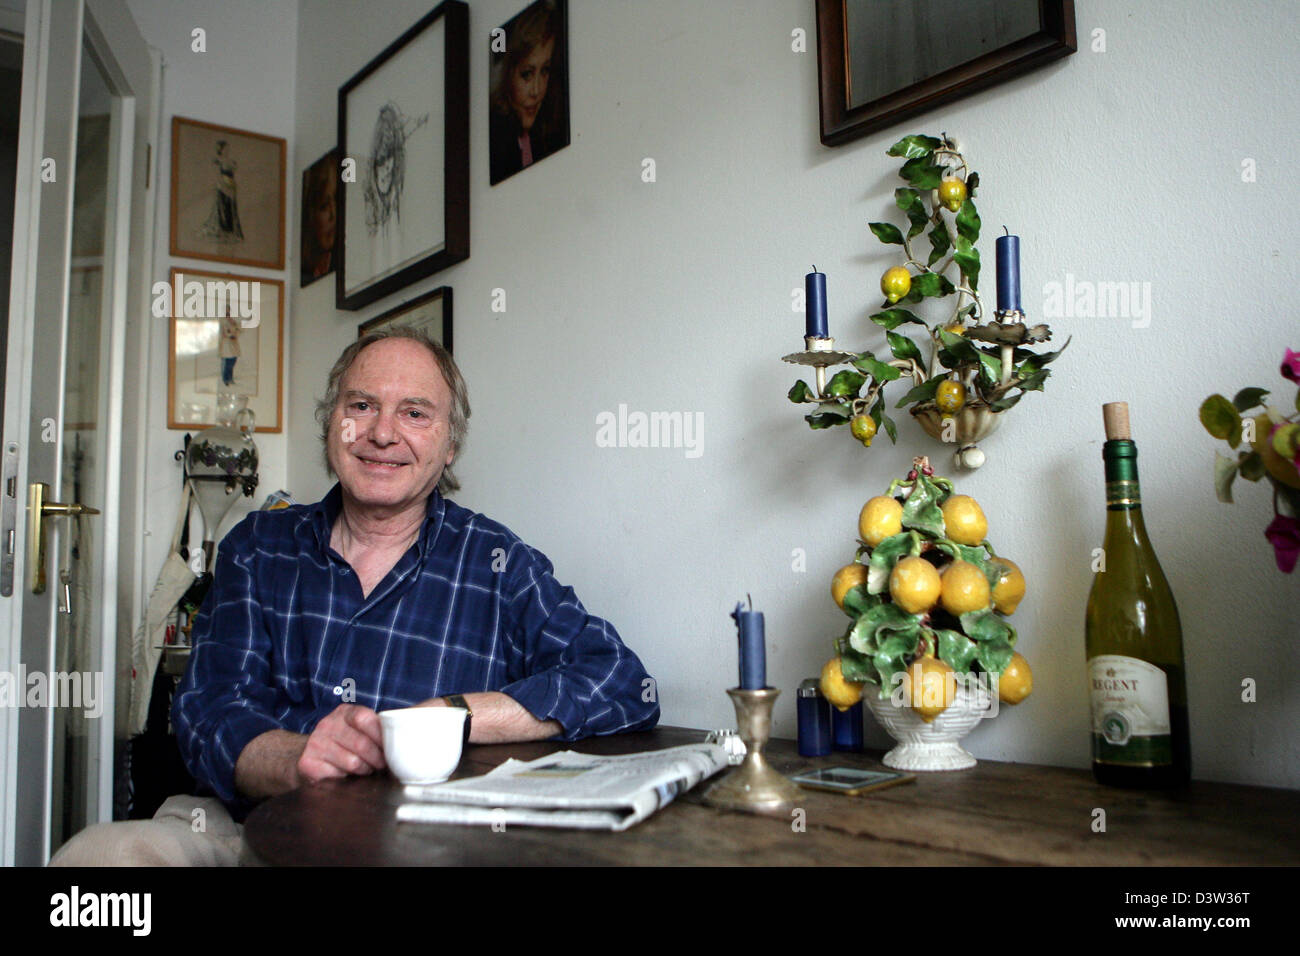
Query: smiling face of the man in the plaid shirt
326 338 455 512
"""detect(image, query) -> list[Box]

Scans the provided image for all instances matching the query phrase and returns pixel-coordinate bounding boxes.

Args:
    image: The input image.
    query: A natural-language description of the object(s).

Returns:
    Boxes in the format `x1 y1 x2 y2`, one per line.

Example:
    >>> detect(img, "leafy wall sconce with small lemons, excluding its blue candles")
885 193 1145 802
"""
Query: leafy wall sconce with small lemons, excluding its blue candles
788 134 1069 468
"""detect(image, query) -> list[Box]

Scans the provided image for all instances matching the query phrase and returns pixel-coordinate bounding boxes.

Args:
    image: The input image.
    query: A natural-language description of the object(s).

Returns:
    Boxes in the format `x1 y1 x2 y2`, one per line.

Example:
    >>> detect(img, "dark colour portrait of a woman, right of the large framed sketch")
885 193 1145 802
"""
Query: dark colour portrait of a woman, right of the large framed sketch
488 0 569 186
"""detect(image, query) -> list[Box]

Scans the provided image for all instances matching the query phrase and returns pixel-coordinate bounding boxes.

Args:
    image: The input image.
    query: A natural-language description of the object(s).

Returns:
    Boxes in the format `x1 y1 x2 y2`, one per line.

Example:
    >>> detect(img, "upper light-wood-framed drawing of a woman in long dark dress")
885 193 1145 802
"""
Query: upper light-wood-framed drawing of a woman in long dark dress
170 116 285 269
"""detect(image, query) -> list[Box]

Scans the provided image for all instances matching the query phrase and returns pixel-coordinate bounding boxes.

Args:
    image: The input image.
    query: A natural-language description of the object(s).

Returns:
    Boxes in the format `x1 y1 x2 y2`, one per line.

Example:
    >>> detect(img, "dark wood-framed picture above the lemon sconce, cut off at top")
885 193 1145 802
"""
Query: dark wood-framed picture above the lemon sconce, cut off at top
816 0 1078 146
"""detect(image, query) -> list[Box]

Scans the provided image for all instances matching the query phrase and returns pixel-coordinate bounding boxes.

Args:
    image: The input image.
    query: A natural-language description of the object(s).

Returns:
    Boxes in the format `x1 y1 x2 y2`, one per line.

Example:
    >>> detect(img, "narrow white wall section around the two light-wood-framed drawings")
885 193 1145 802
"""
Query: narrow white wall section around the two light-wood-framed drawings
127 0 298 594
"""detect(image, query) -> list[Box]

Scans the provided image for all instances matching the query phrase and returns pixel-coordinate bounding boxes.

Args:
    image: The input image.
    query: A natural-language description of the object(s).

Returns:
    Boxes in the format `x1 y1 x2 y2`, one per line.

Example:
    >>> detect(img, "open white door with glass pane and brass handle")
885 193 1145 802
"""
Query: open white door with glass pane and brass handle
0 0 155 865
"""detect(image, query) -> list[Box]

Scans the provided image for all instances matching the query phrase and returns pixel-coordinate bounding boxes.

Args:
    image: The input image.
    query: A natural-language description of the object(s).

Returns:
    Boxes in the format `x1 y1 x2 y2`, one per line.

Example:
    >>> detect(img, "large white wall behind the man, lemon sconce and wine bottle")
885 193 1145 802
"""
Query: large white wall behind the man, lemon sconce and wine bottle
287 0 1300 787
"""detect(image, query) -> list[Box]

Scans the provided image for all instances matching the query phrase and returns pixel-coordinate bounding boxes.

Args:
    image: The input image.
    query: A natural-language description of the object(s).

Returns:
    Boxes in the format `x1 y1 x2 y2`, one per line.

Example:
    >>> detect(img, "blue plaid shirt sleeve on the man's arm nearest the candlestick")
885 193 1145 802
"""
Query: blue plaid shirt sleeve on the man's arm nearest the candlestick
501 544 659 740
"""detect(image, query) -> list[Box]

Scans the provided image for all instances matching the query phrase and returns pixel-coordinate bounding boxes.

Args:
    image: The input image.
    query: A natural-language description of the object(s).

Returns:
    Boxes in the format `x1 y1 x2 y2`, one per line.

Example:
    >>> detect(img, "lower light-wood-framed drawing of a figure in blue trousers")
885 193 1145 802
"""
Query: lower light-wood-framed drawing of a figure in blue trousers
166 269 285 432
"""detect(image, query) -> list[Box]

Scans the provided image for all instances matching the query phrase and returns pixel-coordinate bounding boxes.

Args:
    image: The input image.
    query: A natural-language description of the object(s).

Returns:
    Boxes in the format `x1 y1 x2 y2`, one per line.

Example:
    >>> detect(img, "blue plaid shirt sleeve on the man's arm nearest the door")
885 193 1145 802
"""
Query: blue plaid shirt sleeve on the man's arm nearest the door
172 515 282 804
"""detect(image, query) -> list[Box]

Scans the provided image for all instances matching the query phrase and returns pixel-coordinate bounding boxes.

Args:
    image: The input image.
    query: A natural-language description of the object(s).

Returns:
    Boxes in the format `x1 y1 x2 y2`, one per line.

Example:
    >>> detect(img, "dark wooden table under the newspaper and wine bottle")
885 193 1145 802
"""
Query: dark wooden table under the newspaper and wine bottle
244 727 1300 866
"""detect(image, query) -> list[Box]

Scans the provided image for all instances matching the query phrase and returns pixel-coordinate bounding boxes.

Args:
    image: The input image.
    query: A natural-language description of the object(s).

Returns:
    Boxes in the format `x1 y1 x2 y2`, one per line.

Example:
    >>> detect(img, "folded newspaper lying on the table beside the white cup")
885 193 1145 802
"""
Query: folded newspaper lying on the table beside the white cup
398 743 727 830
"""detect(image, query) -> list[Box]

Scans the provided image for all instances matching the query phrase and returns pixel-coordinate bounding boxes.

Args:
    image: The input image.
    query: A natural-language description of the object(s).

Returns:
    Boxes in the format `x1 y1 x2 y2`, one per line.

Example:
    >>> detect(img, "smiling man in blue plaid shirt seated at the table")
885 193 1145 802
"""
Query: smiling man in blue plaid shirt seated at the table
52 328 659 865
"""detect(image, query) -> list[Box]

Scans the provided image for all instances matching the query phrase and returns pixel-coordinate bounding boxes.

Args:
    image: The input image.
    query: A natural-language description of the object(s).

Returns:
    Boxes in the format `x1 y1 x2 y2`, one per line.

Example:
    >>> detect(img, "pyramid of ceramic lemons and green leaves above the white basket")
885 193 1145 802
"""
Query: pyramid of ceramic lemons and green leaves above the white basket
822 458 1034 738
